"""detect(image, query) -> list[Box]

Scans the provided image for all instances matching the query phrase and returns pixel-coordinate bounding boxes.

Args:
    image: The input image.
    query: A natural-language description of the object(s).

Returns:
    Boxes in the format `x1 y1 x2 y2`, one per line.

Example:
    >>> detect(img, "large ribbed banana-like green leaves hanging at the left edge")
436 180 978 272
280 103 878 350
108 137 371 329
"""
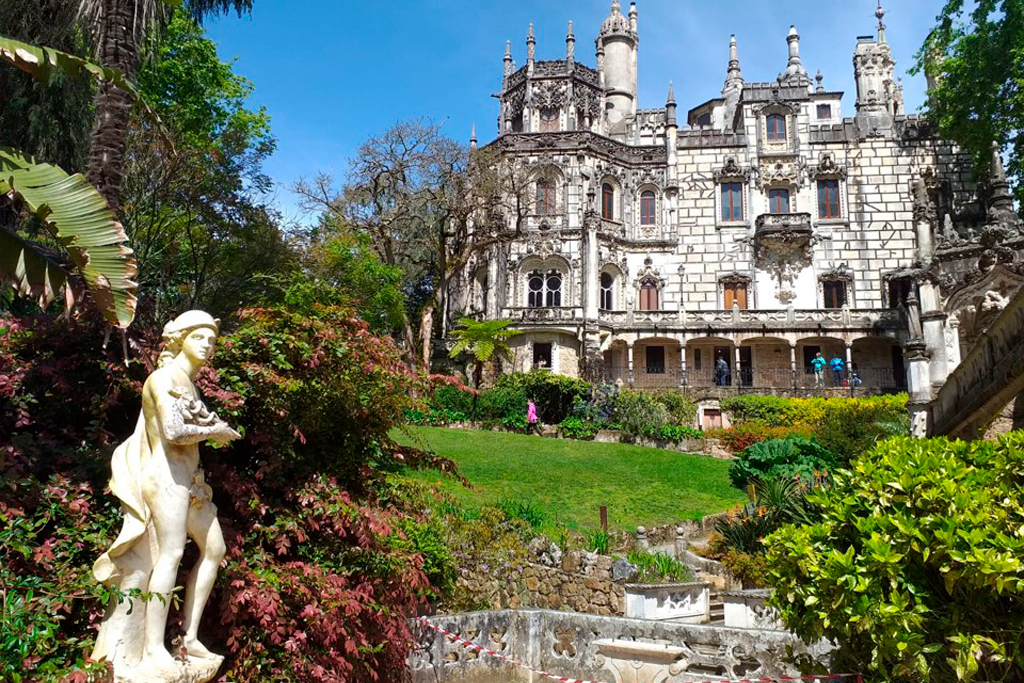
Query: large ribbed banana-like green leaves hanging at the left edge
0 37 136 329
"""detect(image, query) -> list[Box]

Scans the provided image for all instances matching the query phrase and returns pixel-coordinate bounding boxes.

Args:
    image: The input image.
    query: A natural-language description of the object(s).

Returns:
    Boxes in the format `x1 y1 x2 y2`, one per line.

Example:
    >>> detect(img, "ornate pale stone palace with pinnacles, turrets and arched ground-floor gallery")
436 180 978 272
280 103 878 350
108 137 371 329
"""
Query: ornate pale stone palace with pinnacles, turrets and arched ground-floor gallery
452 2 1020 421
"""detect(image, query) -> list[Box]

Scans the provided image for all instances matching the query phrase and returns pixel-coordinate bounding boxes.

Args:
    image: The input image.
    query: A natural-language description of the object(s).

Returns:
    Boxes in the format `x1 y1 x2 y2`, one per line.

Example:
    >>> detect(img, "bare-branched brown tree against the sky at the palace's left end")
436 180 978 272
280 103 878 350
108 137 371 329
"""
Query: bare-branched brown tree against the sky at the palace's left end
295 122 529 368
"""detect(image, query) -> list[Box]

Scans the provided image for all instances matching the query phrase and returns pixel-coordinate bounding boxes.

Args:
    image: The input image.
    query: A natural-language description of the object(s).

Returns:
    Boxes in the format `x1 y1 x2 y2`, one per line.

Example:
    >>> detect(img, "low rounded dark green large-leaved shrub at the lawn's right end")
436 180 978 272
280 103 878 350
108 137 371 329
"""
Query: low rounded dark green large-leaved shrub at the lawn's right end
729 436 837 488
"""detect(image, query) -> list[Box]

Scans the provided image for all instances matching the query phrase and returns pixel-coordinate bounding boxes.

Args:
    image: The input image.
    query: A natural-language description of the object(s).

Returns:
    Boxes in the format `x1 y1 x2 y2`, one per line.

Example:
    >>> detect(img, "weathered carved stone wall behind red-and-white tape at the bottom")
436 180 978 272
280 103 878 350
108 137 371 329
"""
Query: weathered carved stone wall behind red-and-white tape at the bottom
409 610 830 683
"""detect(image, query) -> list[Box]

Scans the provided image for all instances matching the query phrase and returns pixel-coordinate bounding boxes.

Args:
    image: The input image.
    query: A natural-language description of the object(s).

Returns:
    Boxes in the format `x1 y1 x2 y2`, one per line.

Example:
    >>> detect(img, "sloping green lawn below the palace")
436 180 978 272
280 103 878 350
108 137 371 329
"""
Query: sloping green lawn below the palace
396 427 745 529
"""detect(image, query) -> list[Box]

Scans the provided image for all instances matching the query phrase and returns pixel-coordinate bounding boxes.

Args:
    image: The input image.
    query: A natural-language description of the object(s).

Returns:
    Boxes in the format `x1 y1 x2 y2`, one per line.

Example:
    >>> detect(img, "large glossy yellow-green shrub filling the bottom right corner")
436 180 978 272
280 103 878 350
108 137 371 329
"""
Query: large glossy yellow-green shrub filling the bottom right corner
766 432 1024 683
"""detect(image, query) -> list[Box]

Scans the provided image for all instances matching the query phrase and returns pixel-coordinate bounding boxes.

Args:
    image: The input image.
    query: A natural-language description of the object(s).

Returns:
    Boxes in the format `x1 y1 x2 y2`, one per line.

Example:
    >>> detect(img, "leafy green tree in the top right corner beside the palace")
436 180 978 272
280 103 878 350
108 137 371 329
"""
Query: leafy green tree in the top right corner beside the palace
913 0 1024 205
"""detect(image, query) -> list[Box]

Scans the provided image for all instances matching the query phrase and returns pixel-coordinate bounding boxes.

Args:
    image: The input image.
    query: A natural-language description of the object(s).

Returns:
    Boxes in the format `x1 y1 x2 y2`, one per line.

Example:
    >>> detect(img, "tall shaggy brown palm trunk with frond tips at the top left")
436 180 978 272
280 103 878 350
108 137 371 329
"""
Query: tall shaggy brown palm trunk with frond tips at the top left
76 0 252 212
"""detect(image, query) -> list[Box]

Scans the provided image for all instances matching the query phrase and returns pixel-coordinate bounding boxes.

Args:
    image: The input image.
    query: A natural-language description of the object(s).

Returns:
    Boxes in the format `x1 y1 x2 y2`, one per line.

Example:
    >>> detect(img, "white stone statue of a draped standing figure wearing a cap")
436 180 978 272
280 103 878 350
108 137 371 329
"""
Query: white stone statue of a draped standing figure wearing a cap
92 310 240 683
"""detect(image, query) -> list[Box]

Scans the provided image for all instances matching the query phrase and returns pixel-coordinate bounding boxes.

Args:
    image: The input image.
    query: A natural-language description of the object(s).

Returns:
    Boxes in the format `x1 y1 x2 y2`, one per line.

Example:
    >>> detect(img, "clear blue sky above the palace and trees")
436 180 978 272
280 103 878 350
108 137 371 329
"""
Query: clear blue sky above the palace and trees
207 0 942 218
